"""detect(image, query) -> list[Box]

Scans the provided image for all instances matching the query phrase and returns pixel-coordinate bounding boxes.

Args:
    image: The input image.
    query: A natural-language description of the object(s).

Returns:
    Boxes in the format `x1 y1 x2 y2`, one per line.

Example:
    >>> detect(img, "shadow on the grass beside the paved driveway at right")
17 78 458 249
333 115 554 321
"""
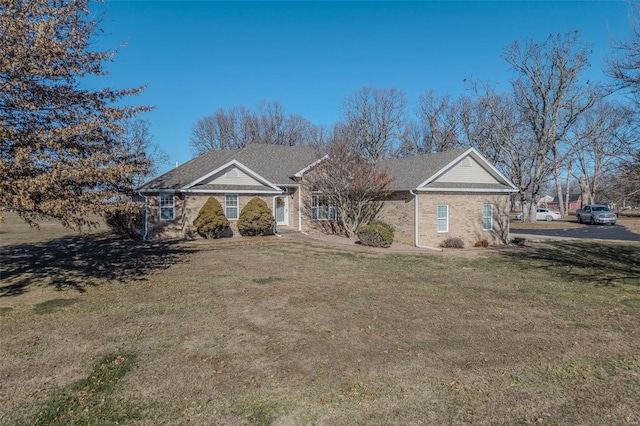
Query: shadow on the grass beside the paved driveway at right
504 241 640 286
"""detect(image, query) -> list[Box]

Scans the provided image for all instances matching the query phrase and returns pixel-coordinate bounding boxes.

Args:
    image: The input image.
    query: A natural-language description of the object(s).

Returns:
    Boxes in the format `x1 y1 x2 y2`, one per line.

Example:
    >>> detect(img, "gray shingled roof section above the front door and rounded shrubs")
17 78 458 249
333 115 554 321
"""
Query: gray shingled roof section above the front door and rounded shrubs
140 144 318 191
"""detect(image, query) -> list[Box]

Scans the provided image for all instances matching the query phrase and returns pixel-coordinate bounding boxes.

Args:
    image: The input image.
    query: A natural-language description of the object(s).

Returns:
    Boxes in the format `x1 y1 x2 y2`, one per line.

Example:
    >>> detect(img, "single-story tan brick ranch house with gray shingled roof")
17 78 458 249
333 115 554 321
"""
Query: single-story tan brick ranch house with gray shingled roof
139 144 517 248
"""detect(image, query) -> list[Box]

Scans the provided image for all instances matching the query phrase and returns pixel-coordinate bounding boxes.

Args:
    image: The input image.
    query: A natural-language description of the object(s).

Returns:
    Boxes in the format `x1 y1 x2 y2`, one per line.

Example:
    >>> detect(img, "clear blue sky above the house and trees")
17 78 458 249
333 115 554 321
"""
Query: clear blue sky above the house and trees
92 0 629 175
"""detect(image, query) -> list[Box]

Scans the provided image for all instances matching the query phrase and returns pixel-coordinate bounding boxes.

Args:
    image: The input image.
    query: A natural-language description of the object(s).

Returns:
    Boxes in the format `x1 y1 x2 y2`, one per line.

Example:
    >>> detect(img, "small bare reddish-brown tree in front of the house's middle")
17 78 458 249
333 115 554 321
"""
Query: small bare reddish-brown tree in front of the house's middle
309 130 392 238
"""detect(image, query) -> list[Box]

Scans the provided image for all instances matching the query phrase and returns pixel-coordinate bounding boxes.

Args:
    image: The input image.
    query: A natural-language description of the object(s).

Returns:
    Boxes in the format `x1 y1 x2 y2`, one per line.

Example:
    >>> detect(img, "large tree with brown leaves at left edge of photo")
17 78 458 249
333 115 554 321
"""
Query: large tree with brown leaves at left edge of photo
0 0 145 227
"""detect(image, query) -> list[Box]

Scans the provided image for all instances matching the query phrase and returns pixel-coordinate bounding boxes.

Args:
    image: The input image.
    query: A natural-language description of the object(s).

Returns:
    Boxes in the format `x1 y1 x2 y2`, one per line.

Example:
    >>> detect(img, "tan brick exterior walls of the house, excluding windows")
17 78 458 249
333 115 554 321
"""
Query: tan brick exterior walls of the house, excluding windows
148 187 509 247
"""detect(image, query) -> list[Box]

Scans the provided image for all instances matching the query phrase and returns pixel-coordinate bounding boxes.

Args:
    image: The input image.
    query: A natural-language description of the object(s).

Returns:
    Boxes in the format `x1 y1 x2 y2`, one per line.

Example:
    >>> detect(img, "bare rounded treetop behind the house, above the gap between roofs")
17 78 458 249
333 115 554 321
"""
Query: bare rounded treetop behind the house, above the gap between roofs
340 86 407 163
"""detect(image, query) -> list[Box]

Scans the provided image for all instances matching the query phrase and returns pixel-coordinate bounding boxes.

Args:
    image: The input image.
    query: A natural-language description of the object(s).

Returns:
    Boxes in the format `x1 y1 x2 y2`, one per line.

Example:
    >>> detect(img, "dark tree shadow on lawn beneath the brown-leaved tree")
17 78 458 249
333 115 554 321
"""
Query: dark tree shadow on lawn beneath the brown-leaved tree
0 234 192 297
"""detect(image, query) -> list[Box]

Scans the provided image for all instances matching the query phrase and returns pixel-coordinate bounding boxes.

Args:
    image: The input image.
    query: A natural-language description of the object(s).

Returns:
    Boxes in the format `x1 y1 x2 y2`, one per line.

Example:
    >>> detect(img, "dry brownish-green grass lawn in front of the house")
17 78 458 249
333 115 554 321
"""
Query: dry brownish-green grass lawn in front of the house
0 215 640 425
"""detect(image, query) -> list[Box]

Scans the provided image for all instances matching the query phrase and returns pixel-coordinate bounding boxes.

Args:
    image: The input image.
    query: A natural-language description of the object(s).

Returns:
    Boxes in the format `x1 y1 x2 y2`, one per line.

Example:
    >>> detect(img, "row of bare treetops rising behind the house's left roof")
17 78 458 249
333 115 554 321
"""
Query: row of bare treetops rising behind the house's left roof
190 102 322 155
